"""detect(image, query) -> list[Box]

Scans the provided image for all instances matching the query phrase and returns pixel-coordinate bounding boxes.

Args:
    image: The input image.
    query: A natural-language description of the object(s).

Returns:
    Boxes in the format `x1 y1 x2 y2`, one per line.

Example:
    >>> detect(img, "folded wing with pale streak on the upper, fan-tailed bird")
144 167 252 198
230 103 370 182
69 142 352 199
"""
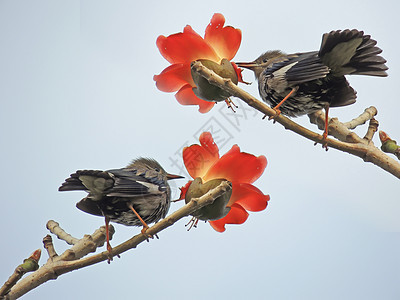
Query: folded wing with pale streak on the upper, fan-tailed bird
264 51 329 87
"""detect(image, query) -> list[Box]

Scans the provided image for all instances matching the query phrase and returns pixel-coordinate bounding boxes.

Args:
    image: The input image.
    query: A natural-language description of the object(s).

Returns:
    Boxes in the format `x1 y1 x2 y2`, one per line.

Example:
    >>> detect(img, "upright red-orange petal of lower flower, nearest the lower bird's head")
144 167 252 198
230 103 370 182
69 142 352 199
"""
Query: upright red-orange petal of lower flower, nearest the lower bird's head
182 132 219 178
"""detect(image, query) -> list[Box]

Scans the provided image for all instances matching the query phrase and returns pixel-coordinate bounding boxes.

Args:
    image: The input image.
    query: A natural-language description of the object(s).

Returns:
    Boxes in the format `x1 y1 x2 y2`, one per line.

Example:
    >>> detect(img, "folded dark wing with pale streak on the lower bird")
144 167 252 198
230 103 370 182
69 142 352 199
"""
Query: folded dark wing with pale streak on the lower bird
106 169 166 197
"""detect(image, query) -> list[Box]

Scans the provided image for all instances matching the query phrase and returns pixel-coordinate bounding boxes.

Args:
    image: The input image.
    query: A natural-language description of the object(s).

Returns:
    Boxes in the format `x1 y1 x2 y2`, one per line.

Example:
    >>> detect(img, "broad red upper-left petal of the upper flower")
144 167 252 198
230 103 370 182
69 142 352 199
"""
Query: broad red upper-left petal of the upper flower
156 25 219 64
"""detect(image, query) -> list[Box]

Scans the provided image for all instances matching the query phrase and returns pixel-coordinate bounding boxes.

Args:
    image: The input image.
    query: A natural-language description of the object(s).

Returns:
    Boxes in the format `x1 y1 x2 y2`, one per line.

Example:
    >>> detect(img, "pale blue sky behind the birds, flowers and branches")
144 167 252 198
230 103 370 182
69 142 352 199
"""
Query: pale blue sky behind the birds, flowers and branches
0 0 400 299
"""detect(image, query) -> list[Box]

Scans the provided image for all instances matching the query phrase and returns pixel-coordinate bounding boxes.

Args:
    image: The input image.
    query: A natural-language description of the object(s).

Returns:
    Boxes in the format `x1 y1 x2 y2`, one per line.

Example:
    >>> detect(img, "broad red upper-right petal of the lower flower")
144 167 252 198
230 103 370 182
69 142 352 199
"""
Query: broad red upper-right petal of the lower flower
203 145 267 183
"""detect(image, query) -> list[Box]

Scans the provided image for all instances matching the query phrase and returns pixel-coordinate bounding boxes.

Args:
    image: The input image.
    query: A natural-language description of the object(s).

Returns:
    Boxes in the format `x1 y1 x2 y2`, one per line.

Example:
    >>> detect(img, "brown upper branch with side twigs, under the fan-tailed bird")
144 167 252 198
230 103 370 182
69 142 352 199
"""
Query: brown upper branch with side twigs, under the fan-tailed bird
192 61 400 179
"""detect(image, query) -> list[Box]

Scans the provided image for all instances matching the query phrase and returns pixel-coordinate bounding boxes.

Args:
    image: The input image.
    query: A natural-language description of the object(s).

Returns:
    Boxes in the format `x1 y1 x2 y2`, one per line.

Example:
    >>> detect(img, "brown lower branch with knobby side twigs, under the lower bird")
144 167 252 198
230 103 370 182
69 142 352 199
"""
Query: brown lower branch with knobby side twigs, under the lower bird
3 181 232 300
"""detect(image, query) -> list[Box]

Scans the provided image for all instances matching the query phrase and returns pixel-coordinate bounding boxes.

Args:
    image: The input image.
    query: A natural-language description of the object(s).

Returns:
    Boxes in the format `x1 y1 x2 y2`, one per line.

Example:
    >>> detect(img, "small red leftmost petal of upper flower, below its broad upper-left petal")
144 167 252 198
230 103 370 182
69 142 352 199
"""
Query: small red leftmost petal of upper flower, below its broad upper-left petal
153 63 195 93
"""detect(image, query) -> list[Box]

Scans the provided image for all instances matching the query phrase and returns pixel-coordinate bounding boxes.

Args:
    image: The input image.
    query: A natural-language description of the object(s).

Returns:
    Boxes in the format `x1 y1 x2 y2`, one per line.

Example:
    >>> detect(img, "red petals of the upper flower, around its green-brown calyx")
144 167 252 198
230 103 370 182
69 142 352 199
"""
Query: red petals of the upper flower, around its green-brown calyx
153 14 243 113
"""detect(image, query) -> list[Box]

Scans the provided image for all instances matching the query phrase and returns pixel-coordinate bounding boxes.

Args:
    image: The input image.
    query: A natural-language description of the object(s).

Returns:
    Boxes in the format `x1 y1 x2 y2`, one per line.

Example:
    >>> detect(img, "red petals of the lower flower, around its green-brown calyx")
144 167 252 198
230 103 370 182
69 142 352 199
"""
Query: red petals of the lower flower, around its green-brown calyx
180 132 270 232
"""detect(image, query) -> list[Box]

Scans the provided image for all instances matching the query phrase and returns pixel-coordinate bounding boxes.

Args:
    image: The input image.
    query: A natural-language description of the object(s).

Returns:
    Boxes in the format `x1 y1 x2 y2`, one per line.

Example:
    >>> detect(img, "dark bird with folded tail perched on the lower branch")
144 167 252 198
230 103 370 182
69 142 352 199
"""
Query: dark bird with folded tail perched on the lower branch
58 157 184 261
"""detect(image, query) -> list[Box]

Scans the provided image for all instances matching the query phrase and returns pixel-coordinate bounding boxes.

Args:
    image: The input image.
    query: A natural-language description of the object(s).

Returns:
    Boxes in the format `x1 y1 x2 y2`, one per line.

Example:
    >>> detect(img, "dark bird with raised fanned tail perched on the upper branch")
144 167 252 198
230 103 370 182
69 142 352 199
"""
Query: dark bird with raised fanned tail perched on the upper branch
236 29 388 145
